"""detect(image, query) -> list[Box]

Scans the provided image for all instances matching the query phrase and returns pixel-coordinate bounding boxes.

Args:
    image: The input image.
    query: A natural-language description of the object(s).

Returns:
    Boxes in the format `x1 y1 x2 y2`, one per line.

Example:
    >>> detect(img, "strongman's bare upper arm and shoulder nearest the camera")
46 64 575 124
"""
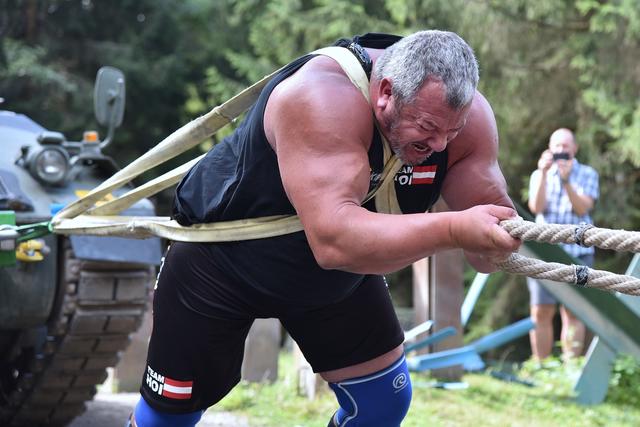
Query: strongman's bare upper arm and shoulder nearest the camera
265 79 373 226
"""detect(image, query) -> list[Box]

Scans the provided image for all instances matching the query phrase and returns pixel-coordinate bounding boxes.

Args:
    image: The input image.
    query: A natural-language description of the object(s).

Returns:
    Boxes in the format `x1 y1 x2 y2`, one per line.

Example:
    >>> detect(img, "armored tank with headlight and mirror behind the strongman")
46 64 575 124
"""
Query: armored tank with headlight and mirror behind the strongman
0 67 161 427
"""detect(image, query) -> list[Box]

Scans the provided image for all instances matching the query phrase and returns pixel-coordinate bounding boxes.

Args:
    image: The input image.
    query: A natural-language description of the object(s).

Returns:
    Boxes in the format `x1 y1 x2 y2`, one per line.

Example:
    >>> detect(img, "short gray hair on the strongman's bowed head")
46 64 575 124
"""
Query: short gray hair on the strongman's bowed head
373 30 479 110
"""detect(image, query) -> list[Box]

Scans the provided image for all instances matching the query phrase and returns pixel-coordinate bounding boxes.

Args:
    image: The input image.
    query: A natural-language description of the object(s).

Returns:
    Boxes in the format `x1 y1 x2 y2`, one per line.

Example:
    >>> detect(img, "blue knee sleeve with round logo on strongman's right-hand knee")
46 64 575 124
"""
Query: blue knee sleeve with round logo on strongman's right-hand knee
329 355 411 427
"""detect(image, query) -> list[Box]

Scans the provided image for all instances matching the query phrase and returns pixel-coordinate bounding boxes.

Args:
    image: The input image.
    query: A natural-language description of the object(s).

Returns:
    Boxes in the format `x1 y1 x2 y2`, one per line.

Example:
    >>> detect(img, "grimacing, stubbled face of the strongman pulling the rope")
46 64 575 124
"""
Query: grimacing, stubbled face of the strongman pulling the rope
381 81 470 165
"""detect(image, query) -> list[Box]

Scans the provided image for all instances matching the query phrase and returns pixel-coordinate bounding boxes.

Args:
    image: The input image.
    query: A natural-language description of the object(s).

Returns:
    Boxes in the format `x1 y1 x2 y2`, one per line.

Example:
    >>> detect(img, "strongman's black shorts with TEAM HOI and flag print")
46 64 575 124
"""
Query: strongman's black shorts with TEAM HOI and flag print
140 242 404 413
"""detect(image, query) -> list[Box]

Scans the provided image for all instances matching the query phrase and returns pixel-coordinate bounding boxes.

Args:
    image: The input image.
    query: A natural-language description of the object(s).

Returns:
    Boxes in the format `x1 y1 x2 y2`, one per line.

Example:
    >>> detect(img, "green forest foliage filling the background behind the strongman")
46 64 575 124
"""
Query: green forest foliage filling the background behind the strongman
0 0 640 354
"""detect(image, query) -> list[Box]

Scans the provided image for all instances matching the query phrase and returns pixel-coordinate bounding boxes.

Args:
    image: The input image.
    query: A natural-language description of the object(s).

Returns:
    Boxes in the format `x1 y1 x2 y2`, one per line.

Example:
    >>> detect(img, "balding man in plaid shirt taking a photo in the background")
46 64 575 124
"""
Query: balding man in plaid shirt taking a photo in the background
527 128 599 360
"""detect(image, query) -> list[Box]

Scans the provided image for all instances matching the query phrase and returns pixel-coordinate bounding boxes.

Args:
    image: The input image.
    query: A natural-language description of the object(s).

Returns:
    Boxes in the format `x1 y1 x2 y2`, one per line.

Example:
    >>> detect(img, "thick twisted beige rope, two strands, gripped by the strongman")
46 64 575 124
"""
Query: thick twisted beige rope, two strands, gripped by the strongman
495 220 640 295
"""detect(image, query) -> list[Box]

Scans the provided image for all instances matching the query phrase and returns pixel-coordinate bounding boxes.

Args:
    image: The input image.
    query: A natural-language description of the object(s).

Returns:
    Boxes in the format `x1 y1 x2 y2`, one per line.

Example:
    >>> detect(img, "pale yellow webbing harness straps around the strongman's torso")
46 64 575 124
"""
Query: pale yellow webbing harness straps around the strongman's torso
51 47 402 242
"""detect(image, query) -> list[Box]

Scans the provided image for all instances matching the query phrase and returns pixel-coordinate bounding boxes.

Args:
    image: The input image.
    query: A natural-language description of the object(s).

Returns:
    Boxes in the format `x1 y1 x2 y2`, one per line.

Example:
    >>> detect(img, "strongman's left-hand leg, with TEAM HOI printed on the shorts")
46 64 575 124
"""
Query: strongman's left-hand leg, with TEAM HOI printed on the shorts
132 243 253 427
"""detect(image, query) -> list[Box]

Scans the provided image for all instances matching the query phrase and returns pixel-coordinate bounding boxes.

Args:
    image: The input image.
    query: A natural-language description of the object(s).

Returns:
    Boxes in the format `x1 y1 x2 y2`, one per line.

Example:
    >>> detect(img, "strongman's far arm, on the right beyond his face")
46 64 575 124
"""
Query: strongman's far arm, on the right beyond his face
442 92 514 272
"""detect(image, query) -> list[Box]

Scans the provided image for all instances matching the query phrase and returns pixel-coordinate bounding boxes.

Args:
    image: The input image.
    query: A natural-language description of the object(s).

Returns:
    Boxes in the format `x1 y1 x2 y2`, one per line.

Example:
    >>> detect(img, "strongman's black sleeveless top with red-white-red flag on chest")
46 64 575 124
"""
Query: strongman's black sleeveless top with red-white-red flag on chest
173 34 447 307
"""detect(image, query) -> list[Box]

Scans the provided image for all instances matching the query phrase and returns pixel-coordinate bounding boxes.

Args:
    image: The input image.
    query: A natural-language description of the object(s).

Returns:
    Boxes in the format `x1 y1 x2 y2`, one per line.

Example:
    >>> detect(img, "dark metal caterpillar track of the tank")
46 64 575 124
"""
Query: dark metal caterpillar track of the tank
0 238 155 427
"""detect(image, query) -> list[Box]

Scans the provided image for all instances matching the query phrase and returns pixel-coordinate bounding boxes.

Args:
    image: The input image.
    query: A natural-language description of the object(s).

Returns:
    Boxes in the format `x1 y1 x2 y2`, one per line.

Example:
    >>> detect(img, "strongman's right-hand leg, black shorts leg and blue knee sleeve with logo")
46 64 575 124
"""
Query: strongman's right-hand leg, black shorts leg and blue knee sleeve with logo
281 276 411 427
